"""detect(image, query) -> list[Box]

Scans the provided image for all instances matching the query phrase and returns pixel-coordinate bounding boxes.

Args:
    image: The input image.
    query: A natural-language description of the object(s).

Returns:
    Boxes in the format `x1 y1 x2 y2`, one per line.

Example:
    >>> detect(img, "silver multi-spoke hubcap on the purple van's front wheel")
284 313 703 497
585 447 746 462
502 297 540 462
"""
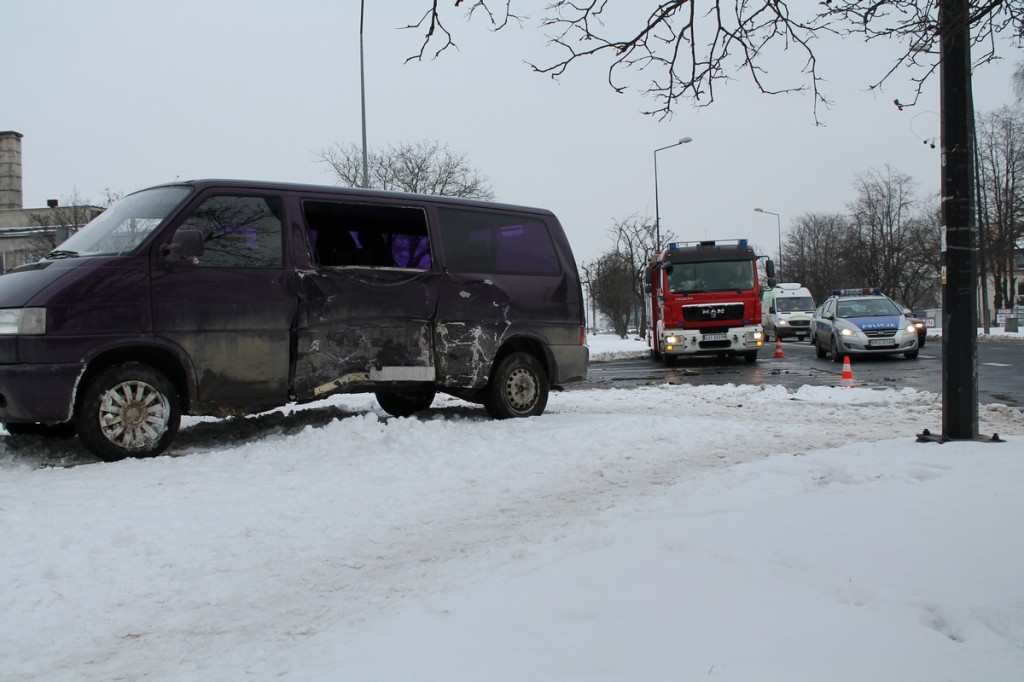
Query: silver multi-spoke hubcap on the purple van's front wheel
99 381 171 450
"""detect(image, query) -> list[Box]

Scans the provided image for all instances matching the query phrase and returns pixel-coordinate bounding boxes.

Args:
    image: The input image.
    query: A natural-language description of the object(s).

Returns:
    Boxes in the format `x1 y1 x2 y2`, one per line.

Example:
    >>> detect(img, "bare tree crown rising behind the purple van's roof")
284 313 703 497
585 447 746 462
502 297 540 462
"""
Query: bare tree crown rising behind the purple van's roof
315 141 495 201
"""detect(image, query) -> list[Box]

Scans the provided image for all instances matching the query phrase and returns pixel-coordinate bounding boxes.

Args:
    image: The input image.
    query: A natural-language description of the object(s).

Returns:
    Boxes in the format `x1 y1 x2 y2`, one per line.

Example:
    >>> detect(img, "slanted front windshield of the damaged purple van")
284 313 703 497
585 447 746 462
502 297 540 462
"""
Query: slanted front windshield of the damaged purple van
46 186 191 260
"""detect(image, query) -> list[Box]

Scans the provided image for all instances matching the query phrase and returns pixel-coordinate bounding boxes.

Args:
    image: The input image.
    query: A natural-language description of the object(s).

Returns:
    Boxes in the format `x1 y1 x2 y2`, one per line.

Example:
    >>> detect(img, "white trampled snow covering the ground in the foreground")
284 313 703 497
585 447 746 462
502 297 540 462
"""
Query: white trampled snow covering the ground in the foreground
0 329 1024 682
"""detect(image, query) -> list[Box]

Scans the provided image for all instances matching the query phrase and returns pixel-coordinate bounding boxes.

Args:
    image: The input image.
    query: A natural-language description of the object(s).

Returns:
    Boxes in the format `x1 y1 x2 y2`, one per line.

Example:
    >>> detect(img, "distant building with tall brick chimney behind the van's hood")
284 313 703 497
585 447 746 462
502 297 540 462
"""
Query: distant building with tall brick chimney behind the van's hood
0 130 103 274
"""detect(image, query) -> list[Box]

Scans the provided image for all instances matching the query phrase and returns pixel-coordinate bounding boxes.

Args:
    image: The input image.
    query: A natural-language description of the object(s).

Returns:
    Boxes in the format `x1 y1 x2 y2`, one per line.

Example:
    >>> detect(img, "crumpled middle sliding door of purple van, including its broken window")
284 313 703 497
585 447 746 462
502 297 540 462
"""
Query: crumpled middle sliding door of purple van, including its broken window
294 198 441 400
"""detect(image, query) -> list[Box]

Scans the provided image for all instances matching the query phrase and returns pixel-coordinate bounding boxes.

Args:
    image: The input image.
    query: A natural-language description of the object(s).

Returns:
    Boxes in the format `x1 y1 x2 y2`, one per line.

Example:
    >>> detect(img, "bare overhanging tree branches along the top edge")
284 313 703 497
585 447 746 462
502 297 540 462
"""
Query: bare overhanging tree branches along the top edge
404 0 1024 120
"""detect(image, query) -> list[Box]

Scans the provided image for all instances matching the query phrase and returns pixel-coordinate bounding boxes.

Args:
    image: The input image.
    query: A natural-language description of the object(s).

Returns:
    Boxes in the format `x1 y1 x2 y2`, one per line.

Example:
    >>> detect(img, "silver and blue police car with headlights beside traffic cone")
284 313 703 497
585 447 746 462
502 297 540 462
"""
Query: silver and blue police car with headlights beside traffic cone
811 289 920 363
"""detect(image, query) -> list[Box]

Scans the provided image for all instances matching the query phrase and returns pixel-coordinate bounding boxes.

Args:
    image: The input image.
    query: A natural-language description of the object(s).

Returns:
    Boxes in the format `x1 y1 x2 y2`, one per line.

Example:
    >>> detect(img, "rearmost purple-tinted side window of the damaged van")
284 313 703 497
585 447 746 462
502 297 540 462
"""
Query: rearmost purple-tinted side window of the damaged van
437 208 561 274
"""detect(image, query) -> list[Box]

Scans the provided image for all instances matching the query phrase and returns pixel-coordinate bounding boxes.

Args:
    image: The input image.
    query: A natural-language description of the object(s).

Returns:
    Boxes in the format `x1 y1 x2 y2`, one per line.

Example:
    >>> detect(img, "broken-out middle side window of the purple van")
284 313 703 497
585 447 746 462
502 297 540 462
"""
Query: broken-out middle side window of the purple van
302 200 432 270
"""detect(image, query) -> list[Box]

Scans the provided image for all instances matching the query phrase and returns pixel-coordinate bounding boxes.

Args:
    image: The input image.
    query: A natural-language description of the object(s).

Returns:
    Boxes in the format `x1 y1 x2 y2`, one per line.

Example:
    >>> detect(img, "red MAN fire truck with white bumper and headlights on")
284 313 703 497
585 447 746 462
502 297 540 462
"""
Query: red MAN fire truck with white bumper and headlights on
644 240 775 366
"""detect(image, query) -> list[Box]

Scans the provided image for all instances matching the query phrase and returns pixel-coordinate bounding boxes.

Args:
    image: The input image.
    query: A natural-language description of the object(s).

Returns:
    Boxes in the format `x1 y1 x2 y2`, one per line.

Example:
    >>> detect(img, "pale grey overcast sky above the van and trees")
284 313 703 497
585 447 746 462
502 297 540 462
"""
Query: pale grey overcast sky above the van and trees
8 0 1024 261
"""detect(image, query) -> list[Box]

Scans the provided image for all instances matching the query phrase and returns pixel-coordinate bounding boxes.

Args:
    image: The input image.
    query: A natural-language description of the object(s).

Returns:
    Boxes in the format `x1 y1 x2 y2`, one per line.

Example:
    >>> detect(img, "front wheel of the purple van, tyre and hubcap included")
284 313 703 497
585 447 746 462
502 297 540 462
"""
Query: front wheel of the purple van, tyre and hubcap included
74 363 181 462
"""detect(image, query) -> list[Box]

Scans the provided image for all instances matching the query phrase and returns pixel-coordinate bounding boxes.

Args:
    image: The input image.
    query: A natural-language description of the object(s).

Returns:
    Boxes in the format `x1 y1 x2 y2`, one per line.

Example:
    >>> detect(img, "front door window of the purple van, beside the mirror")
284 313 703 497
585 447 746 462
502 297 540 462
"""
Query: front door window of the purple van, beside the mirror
178 197 284 267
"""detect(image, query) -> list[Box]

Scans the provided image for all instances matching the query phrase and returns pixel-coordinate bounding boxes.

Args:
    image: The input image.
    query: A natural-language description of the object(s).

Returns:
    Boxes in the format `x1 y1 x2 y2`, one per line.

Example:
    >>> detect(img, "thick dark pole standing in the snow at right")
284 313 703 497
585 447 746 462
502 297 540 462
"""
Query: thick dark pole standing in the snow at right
939 0 978 439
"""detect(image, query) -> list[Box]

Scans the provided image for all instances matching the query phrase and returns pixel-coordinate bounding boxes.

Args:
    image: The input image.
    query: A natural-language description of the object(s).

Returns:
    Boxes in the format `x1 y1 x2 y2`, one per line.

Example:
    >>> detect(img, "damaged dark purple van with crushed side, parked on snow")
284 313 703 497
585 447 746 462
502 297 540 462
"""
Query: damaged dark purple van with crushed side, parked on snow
0 180 588 460
